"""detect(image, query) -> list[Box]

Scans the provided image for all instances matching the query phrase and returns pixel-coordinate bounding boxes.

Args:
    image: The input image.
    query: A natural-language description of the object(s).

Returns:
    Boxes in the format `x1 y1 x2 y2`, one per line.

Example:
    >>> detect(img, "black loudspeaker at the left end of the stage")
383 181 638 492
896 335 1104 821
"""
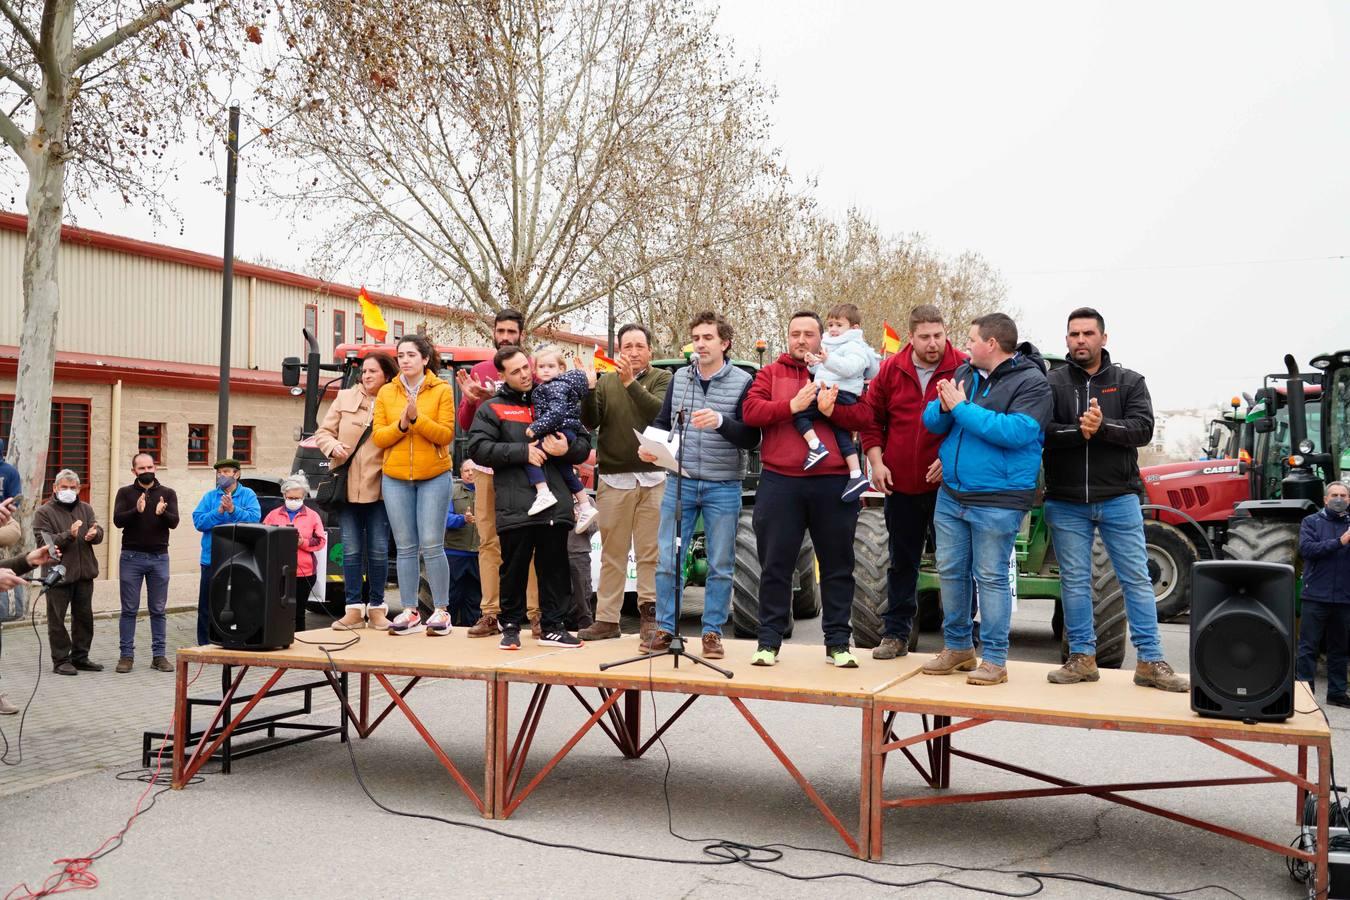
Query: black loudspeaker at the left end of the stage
209 522 296 650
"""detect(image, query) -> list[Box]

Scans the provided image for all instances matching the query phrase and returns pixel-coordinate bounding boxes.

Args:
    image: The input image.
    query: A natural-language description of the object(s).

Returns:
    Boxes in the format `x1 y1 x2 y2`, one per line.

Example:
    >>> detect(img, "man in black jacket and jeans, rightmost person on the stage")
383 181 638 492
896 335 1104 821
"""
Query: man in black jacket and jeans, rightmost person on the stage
1045 306 1189 691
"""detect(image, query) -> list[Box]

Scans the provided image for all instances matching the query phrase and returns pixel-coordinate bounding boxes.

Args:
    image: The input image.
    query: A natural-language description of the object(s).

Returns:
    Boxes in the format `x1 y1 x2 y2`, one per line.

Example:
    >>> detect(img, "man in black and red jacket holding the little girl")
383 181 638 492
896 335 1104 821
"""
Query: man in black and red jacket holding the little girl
467 347 590 650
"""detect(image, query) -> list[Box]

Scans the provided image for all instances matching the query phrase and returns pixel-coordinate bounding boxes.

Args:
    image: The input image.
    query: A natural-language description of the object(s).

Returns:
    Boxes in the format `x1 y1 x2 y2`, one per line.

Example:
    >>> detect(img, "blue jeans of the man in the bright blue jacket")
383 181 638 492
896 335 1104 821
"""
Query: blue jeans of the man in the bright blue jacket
933 487 1026 665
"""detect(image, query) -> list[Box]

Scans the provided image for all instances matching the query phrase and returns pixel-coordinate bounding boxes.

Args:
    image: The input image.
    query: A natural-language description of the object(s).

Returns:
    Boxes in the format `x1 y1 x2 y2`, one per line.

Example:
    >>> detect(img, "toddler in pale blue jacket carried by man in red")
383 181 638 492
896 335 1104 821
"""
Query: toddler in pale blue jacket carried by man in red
792 304 882 501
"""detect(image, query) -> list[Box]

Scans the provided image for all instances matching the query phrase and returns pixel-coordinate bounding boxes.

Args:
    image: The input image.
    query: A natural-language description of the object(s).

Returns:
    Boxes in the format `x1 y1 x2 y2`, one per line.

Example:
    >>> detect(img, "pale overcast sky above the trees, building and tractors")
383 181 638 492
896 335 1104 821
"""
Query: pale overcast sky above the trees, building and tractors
80 0 1350 409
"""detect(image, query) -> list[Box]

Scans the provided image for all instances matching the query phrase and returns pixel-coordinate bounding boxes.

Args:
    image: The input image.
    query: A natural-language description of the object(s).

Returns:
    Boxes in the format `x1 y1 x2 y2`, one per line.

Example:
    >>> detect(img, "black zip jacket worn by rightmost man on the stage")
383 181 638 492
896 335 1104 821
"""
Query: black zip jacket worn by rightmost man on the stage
1045 349 1153 503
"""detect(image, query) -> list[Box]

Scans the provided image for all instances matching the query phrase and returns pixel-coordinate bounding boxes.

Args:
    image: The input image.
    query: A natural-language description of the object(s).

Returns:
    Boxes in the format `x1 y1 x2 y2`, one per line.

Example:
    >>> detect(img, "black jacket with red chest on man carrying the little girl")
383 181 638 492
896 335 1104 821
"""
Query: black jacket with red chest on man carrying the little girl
466 385 590 532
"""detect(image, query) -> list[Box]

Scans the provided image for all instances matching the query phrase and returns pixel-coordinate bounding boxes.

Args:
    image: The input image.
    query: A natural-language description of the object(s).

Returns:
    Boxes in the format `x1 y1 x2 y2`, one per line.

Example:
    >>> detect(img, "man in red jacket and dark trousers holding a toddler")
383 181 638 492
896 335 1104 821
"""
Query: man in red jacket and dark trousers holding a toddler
741 310 861 668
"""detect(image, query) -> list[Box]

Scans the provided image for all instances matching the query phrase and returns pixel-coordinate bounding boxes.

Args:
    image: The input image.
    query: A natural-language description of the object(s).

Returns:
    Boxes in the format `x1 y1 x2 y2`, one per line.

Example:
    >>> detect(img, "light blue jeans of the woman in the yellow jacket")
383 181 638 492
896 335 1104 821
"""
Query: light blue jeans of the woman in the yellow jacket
381 472 454 610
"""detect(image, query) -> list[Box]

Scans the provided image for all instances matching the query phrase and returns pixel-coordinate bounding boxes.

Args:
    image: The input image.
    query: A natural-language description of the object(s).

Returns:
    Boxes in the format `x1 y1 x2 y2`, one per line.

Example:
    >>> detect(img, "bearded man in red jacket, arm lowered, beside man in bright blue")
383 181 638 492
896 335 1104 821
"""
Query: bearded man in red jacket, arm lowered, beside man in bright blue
860 304 965 660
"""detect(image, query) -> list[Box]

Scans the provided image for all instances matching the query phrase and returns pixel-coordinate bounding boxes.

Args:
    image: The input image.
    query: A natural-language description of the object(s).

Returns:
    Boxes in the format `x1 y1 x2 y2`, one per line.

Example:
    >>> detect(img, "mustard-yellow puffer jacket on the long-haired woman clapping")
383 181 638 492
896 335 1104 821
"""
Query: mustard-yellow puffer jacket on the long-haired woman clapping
370 372 455 482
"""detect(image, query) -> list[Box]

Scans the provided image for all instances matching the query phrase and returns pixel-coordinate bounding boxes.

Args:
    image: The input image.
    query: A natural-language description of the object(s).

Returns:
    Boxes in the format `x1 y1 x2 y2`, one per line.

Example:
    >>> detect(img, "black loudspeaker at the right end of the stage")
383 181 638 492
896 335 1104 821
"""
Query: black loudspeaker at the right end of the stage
1191 560 1295 722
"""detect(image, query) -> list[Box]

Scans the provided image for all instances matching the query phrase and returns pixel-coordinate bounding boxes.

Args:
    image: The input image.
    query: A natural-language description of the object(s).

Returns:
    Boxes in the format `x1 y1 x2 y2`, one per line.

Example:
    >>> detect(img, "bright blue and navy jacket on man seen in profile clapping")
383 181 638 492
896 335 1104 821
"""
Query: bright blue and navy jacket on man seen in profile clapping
923 343 1052 510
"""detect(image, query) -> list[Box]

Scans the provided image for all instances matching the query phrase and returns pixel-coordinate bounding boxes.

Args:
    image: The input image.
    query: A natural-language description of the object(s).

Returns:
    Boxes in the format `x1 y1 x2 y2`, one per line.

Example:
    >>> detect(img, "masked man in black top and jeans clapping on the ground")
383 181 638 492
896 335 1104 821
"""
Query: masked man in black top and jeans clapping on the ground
112 453 178 673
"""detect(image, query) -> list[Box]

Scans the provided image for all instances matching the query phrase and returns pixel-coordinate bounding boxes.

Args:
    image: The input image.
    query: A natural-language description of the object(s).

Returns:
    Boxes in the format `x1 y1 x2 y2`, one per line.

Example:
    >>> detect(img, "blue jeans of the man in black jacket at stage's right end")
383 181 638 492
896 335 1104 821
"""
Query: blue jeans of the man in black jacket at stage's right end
1045 494 1162 663
